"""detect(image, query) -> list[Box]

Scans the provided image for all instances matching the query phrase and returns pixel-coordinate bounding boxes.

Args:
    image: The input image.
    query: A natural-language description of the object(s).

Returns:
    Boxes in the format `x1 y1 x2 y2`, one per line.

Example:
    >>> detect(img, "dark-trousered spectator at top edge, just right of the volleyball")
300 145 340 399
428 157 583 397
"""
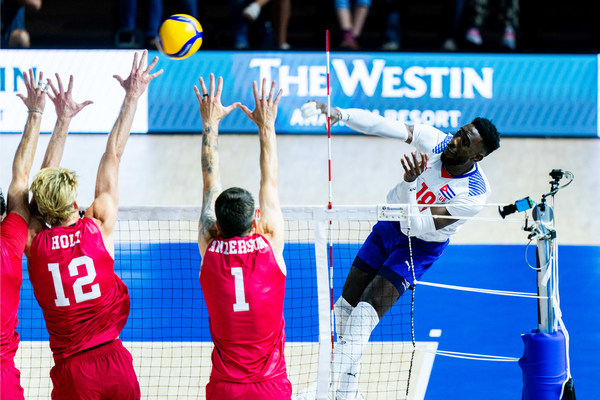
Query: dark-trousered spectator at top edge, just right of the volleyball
230 0 292 50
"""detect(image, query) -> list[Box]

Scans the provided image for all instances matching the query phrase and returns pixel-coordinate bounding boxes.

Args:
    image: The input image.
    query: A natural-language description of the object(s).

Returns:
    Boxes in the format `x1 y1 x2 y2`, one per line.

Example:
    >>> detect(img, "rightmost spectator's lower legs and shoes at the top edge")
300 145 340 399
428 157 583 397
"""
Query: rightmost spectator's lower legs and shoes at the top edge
465 0 519 50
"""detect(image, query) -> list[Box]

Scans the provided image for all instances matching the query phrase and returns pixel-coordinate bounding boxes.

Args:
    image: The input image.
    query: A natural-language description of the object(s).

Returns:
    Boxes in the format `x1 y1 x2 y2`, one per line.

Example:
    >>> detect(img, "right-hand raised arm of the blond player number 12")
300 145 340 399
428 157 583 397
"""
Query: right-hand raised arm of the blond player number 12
85 51 163 252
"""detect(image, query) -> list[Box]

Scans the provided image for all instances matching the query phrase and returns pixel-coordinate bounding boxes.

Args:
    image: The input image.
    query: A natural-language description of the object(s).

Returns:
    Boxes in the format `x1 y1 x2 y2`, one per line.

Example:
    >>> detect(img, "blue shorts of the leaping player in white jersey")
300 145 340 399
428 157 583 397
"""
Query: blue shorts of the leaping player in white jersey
352 221 450 293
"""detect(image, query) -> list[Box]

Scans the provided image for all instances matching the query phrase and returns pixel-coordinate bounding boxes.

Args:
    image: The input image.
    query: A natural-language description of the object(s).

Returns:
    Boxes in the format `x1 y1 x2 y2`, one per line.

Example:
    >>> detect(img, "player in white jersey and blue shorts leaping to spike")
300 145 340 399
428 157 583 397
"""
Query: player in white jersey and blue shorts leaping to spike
299 101 500 400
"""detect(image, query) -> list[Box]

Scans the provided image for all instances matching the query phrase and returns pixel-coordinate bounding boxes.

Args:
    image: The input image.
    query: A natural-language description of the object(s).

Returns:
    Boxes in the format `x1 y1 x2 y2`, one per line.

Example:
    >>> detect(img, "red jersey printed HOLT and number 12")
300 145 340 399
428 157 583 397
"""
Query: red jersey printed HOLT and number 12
28 218 129 360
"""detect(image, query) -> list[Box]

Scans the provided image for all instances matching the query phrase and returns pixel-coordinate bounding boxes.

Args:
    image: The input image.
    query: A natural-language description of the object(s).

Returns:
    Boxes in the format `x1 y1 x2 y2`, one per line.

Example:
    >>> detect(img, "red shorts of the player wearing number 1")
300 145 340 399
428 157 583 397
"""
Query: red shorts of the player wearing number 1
206 375 292 400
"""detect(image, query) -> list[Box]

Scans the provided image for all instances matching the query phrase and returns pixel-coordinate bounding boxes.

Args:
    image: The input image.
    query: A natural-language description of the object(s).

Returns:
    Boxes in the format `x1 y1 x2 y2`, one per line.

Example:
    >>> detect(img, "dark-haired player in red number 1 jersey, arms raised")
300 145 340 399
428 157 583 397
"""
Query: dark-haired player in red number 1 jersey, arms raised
194 74 292 400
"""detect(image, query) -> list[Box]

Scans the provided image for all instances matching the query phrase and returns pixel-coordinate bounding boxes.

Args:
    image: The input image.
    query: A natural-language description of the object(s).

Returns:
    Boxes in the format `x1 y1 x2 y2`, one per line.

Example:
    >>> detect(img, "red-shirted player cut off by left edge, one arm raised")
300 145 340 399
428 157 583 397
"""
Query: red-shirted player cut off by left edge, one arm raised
0 70 46 400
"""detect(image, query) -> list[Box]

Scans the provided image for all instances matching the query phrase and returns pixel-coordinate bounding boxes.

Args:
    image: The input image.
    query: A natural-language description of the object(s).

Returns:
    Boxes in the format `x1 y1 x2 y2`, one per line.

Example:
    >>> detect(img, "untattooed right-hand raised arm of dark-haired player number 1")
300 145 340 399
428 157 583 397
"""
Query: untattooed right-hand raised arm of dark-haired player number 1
240 79 285 266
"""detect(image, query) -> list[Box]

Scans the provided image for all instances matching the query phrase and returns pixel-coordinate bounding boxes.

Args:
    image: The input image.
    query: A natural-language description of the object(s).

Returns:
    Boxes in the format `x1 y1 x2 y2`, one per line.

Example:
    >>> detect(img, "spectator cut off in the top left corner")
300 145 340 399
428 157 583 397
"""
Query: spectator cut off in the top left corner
0 0 42 49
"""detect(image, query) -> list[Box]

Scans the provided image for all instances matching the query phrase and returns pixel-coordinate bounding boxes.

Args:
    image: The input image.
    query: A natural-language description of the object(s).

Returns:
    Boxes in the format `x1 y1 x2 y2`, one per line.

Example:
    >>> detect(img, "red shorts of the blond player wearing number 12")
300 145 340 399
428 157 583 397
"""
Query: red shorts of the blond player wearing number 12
50 339 140 400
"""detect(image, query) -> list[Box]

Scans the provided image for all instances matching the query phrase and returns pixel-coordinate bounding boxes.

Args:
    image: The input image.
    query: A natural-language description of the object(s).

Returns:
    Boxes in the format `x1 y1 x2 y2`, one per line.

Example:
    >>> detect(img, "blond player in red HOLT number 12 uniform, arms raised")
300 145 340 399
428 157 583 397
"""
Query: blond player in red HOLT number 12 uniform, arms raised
26 51 162 400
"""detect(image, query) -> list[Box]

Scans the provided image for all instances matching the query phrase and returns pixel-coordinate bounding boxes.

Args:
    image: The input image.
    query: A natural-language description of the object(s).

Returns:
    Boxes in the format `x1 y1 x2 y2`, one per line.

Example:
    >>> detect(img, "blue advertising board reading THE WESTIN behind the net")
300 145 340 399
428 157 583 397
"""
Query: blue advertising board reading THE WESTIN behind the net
148 51 598 137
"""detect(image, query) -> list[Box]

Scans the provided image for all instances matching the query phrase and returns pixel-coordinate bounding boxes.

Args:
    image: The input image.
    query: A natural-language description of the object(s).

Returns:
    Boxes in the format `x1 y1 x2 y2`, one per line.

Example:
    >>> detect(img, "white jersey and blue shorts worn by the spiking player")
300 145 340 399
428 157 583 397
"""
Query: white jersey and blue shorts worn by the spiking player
352 125 490 294
